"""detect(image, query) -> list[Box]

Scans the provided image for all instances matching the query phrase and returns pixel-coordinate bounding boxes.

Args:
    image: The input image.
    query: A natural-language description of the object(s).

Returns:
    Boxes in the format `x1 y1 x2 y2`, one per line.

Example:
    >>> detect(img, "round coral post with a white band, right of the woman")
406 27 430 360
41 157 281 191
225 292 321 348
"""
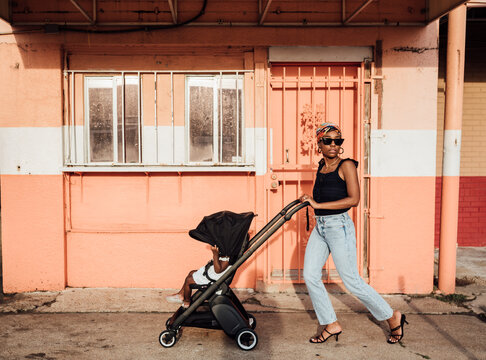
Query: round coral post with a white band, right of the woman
439 5 467 294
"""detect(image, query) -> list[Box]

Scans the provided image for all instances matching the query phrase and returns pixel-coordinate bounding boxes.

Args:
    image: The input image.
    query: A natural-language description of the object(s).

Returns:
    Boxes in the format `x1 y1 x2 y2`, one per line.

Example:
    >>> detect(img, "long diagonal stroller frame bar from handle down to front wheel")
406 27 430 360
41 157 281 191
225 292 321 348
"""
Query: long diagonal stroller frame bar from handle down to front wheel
171 200 310 329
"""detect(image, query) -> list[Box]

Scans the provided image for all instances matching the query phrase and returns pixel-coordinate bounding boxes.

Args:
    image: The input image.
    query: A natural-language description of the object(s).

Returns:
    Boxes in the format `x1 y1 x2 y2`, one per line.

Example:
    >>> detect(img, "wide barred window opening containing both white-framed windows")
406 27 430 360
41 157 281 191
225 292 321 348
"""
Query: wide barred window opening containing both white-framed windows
63 70 254 171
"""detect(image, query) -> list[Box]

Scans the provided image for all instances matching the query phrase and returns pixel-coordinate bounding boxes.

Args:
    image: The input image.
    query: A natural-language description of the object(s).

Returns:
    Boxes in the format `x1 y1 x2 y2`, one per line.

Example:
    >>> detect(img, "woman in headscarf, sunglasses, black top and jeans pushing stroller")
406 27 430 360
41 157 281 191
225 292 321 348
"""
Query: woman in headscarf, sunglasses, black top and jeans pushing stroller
301 123 408 344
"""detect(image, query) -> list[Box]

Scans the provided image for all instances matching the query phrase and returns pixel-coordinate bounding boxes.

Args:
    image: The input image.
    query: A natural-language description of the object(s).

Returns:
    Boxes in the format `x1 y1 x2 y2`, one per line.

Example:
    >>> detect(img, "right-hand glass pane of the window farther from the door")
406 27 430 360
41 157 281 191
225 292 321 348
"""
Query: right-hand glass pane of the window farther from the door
117 76 139 163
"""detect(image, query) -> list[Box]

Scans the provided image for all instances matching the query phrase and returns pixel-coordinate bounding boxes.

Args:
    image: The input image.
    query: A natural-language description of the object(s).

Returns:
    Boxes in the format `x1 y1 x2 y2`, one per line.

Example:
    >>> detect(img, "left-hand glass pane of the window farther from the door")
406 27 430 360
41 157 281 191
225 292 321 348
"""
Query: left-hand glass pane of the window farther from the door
88 79 113 162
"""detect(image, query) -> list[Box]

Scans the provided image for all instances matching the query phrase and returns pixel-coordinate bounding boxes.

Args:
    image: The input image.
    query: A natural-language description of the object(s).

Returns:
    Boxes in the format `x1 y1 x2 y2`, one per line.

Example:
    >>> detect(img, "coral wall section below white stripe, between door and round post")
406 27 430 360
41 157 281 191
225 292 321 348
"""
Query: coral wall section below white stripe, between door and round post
369 177 434 293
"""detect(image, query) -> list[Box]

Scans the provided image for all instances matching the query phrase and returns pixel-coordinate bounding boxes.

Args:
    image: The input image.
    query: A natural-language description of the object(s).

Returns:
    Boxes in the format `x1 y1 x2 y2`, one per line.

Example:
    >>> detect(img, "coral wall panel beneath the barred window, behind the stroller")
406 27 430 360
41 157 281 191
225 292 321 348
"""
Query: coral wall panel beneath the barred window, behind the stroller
65 173 255 288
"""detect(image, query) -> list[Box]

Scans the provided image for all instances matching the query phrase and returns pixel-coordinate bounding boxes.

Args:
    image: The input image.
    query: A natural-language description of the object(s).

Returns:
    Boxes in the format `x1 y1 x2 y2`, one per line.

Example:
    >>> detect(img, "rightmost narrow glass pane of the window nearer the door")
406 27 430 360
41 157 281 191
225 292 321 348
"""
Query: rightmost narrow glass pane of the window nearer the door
218 88 243 163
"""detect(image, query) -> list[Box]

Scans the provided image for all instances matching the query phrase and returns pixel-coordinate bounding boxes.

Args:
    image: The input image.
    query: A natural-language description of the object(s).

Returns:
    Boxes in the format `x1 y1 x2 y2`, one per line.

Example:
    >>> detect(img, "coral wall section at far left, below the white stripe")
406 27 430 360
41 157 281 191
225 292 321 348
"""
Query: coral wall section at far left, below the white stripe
0 175 66 293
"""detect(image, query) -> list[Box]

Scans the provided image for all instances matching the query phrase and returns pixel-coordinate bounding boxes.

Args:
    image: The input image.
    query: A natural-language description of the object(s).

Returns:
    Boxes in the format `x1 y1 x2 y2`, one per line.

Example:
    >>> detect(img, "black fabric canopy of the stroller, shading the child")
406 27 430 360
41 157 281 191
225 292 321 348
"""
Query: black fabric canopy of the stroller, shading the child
189 211 255 256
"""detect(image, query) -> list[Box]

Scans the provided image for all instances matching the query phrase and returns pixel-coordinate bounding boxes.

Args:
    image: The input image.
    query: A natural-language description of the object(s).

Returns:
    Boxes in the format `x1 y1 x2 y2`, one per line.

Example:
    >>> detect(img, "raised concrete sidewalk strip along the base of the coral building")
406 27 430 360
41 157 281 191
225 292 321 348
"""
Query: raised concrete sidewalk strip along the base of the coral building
0 247 486 317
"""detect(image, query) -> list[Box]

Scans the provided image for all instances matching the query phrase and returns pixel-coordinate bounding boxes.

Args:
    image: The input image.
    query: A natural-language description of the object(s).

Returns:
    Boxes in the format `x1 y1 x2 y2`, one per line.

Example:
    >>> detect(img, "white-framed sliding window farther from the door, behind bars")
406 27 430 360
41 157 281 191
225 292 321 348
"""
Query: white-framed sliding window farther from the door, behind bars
85 76 140 163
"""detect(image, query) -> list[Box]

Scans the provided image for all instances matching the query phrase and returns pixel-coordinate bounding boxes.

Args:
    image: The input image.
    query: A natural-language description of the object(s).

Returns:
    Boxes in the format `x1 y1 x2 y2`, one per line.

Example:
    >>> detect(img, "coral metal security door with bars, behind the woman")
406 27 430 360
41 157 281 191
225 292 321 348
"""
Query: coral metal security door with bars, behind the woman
265 64 363 284
